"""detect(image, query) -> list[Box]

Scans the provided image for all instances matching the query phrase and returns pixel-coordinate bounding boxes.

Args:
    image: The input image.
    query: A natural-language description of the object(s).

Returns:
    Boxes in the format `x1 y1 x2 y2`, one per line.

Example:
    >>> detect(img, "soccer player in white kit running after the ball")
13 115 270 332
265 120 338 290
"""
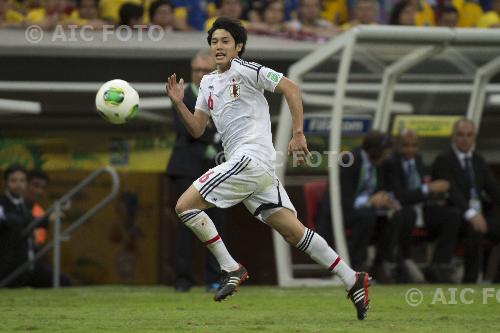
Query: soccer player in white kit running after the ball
167 17 369 320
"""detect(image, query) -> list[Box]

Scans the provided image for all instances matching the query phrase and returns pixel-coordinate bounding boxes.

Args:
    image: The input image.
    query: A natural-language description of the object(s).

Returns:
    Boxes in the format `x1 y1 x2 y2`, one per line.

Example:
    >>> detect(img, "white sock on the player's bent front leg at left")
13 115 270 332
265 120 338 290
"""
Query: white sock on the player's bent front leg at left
179 209 239 272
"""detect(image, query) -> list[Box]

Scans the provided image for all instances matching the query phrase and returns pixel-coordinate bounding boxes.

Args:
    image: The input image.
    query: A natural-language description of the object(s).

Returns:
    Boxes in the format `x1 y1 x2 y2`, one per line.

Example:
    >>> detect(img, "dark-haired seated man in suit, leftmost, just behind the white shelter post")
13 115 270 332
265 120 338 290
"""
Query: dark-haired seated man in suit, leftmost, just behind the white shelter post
316 131 397 282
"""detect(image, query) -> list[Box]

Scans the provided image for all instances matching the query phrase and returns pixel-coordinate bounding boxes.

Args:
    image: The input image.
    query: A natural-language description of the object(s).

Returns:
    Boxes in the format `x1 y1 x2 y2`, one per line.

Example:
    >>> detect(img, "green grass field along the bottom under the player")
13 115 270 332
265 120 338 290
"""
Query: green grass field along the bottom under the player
0 285 500 333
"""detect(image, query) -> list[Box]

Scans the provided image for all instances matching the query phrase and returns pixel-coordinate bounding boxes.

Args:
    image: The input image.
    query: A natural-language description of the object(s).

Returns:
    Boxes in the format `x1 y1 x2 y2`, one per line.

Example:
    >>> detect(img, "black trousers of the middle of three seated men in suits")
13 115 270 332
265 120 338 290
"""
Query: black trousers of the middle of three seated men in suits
394 206 462 264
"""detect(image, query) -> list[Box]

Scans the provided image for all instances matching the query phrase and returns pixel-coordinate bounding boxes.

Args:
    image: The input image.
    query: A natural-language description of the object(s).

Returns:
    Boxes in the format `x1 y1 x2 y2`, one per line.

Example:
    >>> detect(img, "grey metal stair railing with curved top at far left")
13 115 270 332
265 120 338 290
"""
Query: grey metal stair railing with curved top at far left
0 166 120 288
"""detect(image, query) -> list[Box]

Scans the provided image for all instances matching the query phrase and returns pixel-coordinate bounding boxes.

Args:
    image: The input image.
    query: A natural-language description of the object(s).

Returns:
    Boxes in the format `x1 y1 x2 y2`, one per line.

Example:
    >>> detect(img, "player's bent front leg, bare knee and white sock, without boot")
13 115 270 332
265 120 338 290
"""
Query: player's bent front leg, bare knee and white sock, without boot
175 185 239 271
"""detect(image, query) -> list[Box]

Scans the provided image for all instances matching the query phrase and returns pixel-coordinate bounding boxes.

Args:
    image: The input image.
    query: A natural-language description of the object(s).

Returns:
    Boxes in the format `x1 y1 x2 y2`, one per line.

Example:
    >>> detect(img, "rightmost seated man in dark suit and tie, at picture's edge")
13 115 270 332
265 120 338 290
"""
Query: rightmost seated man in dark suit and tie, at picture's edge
432 119 500 283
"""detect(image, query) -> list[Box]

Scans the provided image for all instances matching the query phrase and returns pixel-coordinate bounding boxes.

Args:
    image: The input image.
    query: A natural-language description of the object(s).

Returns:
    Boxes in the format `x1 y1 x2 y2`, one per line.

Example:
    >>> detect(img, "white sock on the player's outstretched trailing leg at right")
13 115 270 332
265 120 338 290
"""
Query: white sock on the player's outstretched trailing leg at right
295 228 356 290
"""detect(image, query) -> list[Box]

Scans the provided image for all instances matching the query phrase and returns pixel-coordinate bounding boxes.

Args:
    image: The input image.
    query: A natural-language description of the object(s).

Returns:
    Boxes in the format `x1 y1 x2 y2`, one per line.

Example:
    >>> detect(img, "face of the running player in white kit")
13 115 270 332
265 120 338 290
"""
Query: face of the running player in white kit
210 29 243 71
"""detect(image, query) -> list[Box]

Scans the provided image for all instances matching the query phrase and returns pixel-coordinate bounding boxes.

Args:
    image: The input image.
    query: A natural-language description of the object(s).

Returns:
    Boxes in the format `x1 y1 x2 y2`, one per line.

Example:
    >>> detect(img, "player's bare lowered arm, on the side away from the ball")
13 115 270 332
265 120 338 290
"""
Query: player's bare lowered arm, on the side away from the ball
274 76 310 164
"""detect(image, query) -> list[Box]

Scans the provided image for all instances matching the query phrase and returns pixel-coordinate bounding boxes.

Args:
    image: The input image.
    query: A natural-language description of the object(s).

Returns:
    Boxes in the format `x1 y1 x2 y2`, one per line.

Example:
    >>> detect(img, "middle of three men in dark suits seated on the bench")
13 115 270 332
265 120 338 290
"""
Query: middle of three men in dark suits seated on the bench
383 129 461 283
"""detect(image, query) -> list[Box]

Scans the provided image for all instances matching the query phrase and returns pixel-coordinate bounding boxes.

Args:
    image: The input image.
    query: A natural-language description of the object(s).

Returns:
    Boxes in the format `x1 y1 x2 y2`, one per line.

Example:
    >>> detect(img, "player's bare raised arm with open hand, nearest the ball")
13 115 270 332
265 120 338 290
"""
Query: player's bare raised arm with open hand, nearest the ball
167 74 209 138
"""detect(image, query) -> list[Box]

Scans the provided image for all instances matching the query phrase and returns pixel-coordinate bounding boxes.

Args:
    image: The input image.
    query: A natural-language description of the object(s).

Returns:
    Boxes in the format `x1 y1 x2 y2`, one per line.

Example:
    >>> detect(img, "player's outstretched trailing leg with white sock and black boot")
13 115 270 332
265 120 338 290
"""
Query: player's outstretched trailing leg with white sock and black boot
264 208 369 320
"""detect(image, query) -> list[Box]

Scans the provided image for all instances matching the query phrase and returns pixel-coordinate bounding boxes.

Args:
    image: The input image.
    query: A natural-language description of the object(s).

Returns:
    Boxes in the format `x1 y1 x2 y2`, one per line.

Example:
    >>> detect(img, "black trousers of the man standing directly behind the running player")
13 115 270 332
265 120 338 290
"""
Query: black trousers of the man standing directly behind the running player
173 178 225 286
